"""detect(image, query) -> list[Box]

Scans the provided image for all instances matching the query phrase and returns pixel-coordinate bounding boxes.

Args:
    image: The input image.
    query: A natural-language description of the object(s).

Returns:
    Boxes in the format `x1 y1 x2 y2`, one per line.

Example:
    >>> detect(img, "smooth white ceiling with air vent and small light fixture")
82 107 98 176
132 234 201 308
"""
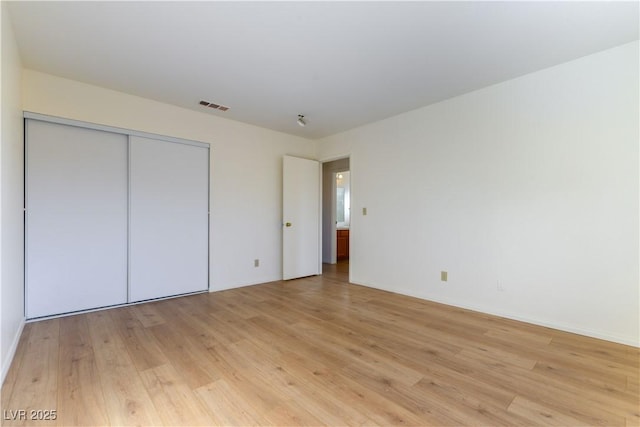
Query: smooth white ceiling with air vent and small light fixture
9 1 639 139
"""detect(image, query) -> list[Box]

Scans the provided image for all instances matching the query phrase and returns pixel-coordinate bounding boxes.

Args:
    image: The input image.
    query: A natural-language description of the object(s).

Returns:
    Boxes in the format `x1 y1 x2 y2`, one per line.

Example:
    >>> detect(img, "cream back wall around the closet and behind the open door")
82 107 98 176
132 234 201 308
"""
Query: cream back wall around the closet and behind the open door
23 70 315 290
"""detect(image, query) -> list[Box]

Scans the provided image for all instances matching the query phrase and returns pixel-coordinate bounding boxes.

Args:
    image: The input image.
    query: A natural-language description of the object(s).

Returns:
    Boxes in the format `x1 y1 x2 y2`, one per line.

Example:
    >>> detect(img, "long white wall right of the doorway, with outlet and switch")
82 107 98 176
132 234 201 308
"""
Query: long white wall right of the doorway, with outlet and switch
318 42 640 346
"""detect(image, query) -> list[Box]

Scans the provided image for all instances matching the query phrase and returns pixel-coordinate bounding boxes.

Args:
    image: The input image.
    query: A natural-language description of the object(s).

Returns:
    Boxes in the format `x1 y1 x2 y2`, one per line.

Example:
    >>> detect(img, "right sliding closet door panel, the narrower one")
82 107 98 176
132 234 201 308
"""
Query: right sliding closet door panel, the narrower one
129 136 209 302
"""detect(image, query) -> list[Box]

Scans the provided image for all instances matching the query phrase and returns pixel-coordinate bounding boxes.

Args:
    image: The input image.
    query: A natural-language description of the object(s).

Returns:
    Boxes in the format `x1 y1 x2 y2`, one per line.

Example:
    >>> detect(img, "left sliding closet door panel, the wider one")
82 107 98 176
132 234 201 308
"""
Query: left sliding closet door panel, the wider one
25 120 128 318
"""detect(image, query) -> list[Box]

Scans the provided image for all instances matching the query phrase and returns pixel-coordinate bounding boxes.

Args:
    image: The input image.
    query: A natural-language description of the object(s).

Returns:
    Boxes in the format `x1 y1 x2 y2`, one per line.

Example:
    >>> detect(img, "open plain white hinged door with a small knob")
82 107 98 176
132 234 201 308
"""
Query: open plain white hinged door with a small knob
282 156 320 280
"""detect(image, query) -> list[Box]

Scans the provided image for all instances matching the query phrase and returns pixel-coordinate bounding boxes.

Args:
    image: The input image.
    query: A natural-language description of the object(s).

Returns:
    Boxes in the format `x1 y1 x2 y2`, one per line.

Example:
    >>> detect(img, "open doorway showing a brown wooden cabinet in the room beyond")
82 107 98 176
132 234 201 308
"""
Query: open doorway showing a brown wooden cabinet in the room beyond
322 157 351 269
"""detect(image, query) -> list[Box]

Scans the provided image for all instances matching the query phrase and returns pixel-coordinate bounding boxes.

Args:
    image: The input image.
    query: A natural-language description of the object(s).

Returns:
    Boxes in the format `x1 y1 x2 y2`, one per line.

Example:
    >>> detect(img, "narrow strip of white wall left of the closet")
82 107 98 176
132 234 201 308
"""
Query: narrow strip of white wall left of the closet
0 2 24 382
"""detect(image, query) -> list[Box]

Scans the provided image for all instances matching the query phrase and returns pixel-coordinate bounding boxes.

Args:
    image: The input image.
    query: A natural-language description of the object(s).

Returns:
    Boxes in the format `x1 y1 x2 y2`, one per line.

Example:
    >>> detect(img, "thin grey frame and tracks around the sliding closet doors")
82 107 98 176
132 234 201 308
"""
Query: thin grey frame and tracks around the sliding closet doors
23 111 211 321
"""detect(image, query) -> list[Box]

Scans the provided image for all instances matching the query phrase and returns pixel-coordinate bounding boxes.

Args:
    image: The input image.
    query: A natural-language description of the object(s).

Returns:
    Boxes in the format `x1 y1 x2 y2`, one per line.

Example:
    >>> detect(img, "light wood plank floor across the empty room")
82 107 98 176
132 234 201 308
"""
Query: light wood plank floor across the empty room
2 266 640 426
